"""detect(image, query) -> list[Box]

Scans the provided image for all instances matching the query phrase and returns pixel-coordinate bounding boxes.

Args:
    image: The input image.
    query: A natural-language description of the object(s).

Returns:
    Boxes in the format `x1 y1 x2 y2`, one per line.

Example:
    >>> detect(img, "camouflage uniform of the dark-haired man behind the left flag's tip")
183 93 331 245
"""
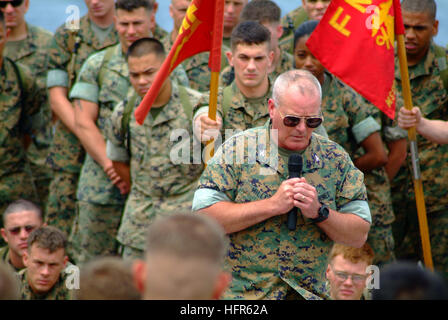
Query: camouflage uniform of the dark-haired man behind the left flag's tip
107 82 203 258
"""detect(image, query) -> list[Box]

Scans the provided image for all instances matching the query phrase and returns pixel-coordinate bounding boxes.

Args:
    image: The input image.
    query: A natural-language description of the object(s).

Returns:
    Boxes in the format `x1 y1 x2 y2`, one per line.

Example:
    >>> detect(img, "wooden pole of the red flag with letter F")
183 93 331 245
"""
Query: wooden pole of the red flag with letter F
397 34 434 271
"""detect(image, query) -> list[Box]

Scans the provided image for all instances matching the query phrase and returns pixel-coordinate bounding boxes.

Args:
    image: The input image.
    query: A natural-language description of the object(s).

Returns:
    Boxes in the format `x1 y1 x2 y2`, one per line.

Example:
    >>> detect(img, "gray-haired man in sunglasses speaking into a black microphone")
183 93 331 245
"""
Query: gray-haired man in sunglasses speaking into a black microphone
193 70 371 299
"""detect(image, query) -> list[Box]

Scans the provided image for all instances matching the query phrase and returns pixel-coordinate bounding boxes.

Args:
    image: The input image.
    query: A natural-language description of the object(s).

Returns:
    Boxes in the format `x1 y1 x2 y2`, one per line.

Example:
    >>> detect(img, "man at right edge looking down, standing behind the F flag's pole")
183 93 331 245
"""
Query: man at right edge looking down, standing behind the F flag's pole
384 0 448 279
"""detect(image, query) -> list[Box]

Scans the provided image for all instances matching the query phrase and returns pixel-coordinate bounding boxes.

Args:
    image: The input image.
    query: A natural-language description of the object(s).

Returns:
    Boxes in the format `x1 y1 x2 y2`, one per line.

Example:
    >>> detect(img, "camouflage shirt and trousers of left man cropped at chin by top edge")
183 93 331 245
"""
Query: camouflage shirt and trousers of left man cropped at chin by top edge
45 15 118 234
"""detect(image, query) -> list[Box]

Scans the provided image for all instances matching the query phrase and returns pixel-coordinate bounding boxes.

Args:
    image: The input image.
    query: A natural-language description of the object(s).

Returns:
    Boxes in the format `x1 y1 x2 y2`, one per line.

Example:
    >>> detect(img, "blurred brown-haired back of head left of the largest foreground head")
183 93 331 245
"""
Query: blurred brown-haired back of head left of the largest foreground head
76 257 140 300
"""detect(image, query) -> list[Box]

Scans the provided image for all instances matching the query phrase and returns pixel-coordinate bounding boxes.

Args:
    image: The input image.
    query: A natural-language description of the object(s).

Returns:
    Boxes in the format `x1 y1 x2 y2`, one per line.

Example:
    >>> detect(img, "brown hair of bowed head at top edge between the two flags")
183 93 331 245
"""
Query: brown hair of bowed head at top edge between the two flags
240 0 281 23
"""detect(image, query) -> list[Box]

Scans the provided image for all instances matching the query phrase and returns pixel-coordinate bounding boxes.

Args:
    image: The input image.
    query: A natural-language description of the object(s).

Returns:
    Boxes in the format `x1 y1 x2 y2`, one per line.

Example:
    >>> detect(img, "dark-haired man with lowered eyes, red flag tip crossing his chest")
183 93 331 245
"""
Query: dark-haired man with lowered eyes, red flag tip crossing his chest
107 39 203 259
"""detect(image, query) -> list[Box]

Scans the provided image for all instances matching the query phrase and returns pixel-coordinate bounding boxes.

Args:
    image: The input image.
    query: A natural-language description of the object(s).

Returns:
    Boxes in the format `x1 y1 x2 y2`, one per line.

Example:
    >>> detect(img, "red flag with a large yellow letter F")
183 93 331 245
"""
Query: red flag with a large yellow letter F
307 0 404 119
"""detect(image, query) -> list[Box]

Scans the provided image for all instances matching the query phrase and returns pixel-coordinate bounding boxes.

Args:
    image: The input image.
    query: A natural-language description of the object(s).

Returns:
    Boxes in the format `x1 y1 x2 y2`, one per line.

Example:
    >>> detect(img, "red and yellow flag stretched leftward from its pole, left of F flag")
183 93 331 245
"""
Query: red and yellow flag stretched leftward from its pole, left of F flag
135 0 224 124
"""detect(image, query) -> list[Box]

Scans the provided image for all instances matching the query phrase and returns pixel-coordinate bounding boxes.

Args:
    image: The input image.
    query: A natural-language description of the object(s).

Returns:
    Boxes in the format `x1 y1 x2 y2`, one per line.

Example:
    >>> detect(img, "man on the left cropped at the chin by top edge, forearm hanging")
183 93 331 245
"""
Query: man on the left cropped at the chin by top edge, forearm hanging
45 0 118 234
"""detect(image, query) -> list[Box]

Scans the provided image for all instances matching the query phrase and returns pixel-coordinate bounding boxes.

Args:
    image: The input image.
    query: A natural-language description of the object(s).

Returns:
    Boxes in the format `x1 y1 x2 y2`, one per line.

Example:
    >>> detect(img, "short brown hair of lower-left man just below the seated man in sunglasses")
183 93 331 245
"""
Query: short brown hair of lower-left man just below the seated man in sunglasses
28 226 67 253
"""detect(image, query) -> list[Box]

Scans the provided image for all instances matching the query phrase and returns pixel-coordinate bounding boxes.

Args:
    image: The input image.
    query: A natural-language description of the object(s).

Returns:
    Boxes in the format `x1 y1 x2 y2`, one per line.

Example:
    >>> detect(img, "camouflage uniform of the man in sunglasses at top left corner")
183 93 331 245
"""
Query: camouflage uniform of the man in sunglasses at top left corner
3 24 53 208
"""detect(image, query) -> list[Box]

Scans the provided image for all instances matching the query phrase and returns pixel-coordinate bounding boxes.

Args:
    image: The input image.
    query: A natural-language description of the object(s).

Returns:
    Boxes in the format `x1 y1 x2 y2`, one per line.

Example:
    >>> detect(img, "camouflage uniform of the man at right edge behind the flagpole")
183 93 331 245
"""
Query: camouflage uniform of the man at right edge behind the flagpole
391 44 448 278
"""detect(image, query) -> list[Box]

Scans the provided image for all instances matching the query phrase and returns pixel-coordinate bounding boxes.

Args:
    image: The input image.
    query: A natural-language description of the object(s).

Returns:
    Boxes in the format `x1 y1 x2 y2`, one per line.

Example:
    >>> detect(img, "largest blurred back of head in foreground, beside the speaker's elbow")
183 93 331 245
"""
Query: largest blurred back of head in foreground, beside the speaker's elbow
145 213 228 300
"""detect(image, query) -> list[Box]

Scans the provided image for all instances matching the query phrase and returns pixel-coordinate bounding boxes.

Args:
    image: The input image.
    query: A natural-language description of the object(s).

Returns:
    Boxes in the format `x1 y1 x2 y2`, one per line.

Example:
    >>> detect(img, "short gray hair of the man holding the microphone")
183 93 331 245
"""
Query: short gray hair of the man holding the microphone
272 70 322 109
